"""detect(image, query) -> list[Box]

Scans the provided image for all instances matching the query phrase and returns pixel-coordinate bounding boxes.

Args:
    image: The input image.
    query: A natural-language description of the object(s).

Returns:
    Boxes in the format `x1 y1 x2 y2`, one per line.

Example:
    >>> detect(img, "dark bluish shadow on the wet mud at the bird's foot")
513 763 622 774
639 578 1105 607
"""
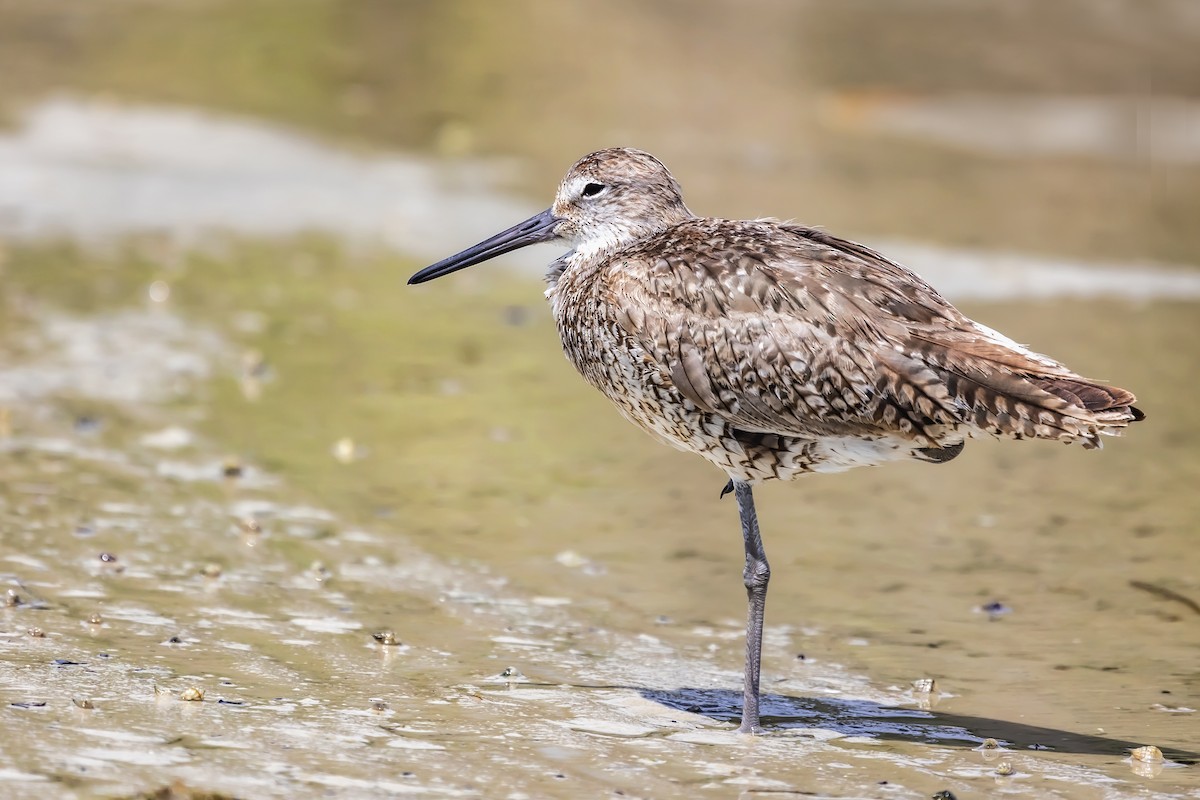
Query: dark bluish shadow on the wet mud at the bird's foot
637 688 1200 765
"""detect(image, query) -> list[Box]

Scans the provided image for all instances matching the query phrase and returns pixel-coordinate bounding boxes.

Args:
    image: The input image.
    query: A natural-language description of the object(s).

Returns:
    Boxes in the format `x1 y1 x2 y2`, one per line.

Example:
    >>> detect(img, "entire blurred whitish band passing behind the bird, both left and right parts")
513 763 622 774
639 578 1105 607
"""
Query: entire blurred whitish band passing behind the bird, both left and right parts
0 96 1200 300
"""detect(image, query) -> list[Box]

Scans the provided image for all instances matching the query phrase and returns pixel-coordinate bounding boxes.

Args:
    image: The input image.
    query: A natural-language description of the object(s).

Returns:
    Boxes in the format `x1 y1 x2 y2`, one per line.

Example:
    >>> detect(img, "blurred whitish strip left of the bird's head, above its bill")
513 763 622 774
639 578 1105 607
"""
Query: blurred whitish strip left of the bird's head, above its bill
0 96 530 260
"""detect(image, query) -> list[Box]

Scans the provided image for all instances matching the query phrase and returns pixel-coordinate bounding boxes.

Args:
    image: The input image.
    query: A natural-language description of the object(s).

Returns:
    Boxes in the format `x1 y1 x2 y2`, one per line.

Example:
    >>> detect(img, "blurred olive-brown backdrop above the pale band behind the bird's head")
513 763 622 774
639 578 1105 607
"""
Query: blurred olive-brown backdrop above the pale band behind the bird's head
0 0 1200 261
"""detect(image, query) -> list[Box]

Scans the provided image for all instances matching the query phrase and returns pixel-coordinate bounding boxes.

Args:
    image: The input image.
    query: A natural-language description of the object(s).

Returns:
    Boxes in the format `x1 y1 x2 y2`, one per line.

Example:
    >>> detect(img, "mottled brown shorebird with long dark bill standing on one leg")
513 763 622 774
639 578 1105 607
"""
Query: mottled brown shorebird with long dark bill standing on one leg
408 148 1144 733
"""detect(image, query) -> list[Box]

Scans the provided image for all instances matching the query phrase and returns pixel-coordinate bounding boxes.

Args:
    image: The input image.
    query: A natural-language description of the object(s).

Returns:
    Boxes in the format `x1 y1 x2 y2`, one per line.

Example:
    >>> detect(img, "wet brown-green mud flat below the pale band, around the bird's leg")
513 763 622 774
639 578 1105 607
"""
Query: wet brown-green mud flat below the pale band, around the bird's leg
0 239 1200 798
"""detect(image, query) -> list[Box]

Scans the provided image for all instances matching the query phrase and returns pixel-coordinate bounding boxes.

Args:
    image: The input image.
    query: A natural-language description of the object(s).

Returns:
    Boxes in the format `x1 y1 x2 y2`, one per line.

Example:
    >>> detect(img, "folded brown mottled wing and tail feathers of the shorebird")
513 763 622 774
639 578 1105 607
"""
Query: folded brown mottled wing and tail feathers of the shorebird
607 219 1142 447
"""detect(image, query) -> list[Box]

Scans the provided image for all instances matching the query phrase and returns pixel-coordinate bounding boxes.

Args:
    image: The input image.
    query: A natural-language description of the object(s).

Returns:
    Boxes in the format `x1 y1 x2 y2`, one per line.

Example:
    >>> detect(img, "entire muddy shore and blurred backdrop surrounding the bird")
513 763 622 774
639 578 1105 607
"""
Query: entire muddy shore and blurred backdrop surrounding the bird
0 0 1200 798
